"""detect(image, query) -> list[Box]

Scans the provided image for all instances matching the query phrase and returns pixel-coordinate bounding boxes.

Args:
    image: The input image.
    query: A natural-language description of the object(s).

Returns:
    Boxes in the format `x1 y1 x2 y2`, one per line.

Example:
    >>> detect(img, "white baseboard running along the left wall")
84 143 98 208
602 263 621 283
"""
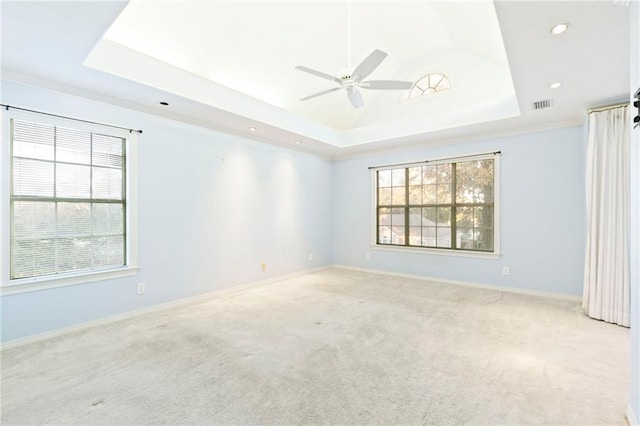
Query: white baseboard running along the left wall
0 265 332 351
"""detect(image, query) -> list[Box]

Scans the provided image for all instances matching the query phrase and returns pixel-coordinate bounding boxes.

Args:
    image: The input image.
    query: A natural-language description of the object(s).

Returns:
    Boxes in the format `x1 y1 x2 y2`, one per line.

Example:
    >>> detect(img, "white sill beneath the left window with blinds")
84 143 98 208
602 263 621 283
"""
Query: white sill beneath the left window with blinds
0 266 138 296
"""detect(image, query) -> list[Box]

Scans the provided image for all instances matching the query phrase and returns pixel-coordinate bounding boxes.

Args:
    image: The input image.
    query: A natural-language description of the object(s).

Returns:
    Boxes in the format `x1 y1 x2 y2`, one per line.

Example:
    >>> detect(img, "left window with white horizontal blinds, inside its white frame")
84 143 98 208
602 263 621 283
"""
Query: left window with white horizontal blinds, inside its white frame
3 110 135 290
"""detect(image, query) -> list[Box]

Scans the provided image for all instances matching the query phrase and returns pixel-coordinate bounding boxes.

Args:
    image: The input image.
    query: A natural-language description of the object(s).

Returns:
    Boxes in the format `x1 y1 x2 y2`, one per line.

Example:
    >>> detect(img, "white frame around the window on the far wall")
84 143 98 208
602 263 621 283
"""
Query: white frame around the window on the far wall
369 150 502 259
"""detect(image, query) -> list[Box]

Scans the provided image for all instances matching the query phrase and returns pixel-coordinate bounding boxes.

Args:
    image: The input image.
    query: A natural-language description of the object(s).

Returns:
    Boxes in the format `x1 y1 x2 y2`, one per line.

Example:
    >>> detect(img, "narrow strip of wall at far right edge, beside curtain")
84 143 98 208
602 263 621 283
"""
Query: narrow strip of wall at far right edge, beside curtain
629 1 640 421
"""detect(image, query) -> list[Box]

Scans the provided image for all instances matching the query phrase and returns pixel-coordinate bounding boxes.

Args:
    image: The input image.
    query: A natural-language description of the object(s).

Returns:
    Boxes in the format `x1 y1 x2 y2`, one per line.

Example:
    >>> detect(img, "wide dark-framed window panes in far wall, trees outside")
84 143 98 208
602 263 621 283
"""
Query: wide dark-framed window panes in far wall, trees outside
375 154 497 253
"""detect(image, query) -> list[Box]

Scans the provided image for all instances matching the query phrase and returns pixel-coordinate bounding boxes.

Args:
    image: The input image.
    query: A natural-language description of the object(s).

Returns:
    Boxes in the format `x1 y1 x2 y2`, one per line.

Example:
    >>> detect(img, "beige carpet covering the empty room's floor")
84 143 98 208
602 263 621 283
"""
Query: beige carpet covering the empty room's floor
2 269 629 425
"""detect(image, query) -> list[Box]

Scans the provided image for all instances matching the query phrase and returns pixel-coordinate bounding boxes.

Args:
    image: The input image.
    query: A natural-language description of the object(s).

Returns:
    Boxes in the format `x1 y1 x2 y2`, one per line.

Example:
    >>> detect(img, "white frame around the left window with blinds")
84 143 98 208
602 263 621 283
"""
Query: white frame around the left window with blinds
0 109 138 296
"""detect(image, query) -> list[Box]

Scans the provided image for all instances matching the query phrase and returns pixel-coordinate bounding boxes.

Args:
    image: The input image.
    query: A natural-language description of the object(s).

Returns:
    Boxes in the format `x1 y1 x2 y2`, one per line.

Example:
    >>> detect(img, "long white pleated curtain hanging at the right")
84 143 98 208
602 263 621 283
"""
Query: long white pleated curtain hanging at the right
582 106 630 327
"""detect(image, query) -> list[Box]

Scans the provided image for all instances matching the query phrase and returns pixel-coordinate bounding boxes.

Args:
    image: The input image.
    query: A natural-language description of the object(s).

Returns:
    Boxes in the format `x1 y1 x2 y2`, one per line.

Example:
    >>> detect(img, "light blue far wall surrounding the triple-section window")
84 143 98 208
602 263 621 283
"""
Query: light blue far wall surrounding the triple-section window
333 126 586 295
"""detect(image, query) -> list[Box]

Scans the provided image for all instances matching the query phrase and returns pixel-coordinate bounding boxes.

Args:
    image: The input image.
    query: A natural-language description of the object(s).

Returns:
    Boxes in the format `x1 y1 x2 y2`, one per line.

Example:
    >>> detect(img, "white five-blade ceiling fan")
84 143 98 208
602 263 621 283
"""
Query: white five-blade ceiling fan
296 49 413 108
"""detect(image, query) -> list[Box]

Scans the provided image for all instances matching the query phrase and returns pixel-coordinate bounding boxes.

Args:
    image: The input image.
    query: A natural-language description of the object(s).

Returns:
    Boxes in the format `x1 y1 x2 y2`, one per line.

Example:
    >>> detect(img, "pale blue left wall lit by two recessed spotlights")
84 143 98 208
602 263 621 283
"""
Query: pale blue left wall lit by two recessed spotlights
1 82 332 341
